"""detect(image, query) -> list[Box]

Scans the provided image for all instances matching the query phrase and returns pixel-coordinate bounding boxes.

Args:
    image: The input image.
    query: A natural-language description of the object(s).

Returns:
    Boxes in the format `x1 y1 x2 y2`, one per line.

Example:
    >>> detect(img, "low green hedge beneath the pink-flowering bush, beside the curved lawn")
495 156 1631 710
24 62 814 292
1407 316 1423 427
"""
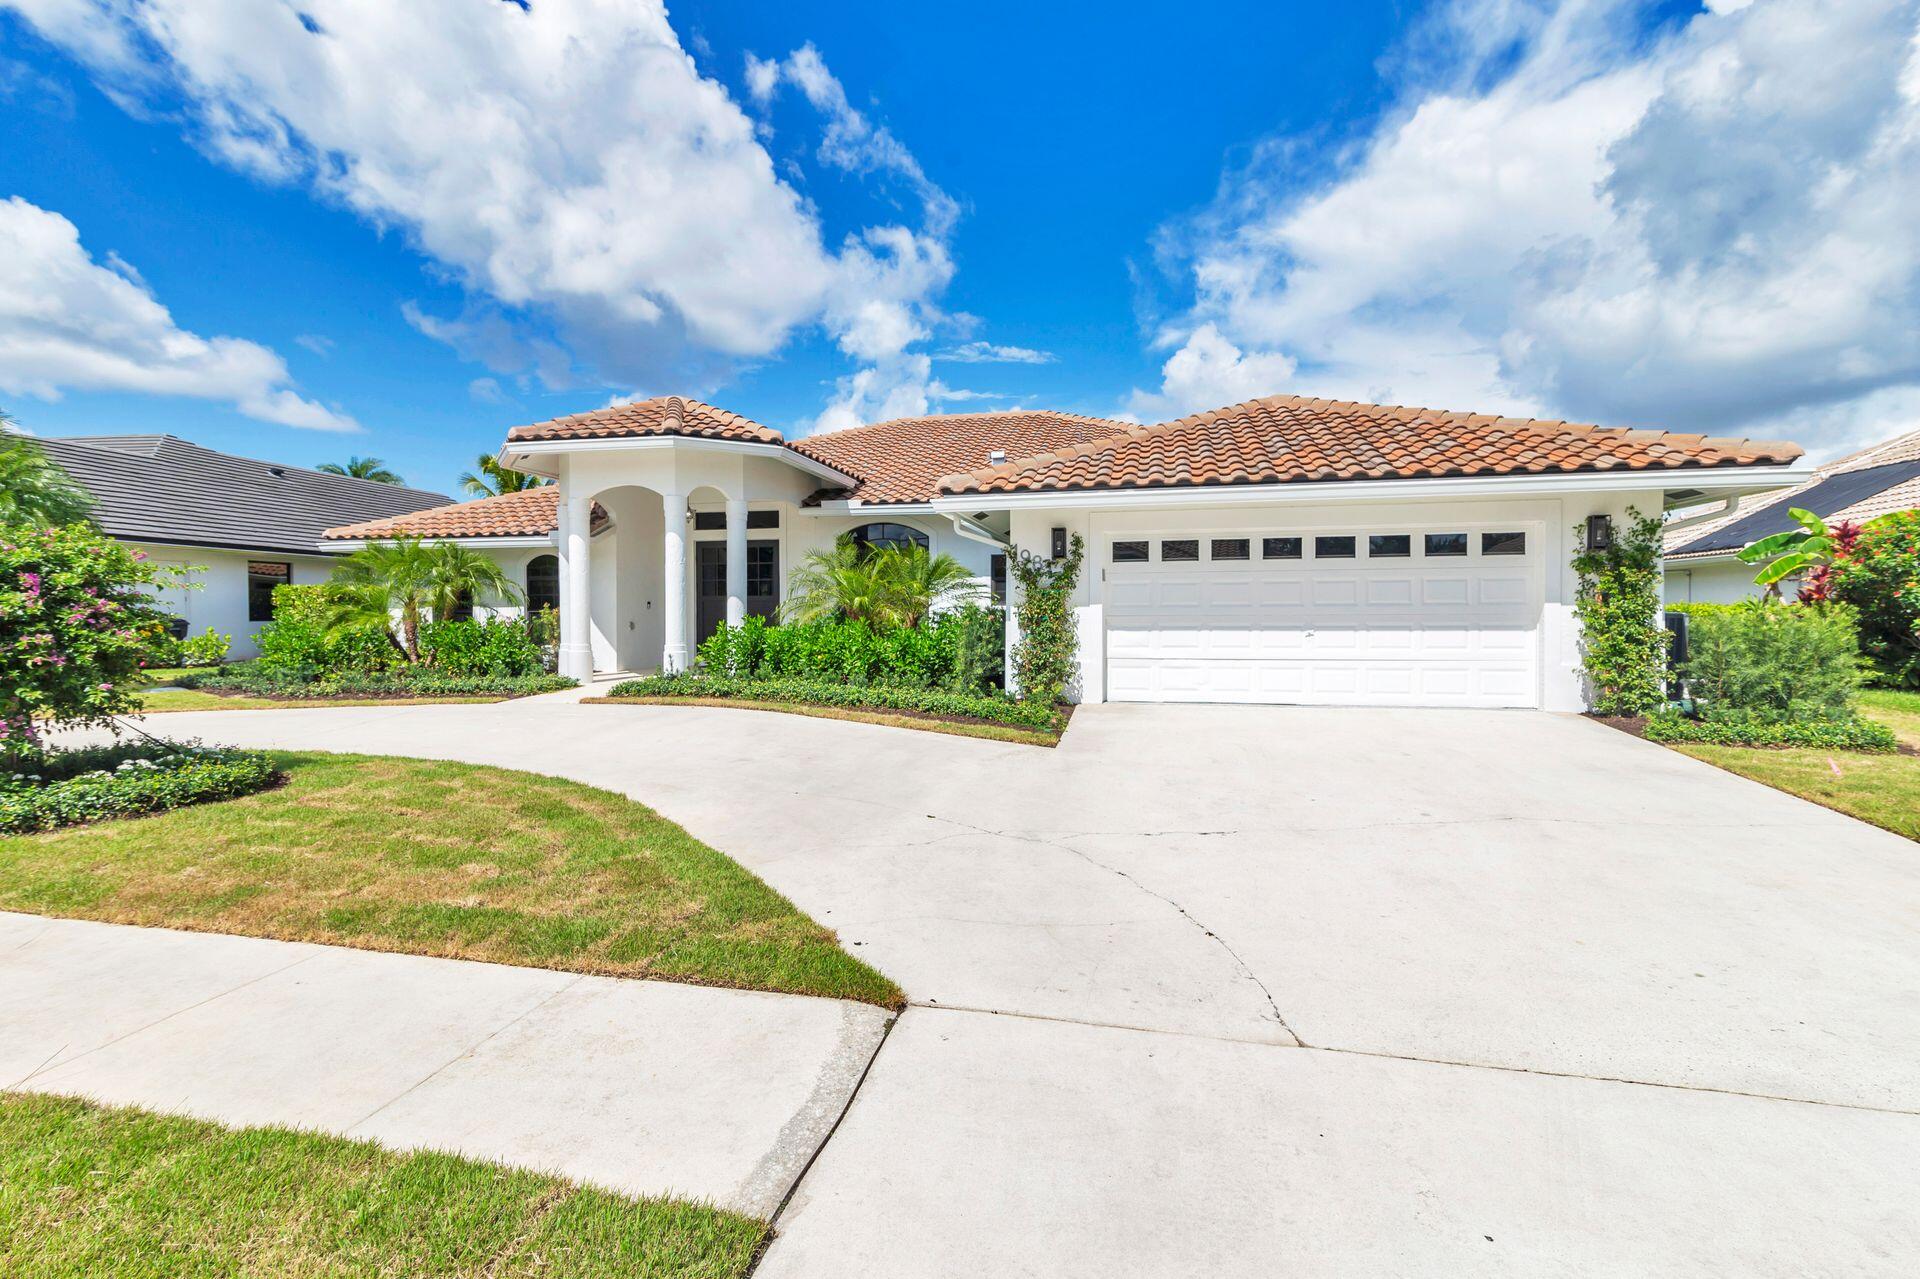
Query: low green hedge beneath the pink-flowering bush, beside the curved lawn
0 739 280 835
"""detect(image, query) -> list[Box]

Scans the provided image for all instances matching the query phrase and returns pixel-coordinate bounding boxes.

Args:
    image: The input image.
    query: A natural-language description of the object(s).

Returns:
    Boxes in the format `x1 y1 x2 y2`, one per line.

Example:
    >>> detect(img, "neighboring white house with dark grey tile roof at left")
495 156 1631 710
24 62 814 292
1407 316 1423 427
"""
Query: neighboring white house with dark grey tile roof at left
36 436 453 657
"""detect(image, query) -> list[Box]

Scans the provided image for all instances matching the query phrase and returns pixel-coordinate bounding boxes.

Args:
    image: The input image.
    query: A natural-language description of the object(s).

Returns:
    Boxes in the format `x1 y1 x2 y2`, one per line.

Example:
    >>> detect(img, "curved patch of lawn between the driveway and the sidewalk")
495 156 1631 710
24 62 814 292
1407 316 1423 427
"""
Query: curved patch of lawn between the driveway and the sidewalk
0 753 902 1008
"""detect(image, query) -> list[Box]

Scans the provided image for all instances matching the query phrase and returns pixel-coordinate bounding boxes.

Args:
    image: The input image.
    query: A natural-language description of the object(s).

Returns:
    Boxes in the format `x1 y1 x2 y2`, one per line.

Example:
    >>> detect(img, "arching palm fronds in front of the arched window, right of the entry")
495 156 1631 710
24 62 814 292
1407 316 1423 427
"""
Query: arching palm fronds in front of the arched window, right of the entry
781 538 981 628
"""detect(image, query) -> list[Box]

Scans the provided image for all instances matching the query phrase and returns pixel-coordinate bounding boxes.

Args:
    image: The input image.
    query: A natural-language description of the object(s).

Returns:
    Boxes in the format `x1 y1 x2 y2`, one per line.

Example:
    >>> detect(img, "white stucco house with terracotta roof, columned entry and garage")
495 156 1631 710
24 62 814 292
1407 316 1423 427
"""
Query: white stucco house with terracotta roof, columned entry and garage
324 396 1809 711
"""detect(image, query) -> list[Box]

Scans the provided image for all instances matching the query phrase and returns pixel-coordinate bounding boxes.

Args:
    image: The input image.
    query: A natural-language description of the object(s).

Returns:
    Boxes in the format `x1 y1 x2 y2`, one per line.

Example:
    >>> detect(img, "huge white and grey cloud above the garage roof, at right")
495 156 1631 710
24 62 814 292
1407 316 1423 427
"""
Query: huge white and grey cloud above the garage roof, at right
1142 0 1920 446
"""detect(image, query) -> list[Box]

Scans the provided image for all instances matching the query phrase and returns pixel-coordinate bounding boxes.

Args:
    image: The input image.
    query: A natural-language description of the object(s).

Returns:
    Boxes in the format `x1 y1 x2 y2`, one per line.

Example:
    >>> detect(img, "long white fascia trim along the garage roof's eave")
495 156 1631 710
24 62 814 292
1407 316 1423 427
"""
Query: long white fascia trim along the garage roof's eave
933 467 1812 515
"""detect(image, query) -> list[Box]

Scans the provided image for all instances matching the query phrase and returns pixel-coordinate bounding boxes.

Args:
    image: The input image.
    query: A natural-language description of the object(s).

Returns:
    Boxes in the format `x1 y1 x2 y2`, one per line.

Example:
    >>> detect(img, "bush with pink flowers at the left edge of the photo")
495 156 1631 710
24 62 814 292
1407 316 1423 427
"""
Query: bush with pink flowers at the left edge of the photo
0 524 171 755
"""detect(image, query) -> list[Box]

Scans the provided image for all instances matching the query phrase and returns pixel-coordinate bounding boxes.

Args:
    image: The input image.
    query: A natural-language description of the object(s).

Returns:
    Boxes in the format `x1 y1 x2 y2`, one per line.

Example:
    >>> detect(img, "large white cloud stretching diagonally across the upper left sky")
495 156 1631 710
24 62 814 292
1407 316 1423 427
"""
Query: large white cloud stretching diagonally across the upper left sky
13 0 956 418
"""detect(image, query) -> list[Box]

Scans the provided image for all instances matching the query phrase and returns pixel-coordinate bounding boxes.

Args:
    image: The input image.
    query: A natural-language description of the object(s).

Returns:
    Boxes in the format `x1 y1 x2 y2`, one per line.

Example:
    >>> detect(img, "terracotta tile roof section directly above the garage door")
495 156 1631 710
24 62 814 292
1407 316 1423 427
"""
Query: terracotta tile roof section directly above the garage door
941 396 1801 494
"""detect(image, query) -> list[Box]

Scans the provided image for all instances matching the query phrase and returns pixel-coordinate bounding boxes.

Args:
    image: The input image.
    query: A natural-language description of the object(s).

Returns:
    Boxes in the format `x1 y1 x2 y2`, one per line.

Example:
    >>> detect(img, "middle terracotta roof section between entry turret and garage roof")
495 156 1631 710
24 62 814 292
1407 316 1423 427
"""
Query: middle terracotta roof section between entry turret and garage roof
789 409 1129 503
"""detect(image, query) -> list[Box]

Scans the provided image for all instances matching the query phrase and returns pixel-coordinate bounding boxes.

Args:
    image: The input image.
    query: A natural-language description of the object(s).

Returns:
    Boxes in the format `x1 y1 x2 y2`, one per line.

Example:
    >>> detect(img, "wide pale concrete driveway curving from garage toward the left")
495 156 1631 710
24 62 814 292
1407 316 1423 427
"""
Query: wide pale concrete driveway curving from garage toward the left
82 699 1920 1275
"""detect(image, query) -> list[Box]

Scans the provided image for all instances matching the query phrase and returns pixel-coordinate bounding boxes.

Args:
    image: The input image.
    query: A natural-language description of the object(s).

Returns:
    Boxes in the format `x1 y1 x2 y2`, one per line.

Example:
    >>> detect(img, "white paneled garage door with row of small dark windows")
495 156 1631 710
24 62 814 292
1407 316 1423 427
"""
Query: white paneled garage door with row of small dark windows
1100 526 1544 707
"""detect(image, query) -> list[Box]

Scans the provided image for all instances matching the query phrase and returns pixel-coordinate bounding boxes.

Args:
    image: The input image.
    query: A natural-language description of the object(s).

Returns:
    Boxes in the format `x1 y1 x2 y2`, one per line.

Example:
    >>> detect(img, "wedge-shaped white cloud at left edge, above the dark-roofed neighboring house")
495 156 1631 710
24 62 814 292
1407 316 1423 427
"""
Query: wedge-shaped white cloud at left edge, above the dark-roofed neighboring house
0 196 359 430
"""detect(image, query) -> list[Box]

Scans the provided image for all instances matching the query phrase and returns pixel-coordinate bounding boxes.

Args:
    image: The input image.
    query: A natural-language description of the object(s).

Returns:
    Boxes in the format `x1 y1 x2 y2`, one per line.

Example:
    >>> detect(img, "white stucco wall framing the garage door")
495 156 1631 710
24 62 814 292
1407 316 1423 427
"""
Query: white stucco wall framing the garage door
983 490 1663 711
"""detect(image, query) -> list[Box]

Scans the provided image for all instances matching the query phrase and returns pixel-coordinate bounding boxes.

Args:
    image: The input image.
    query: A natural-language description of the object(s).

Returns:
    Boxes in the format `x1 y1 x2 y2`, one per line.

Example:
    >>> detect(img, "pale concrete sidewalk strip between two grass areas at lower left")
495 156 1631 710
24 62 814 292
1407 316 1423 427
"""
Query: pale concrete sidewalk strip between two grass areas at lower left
0 912 889 1219
